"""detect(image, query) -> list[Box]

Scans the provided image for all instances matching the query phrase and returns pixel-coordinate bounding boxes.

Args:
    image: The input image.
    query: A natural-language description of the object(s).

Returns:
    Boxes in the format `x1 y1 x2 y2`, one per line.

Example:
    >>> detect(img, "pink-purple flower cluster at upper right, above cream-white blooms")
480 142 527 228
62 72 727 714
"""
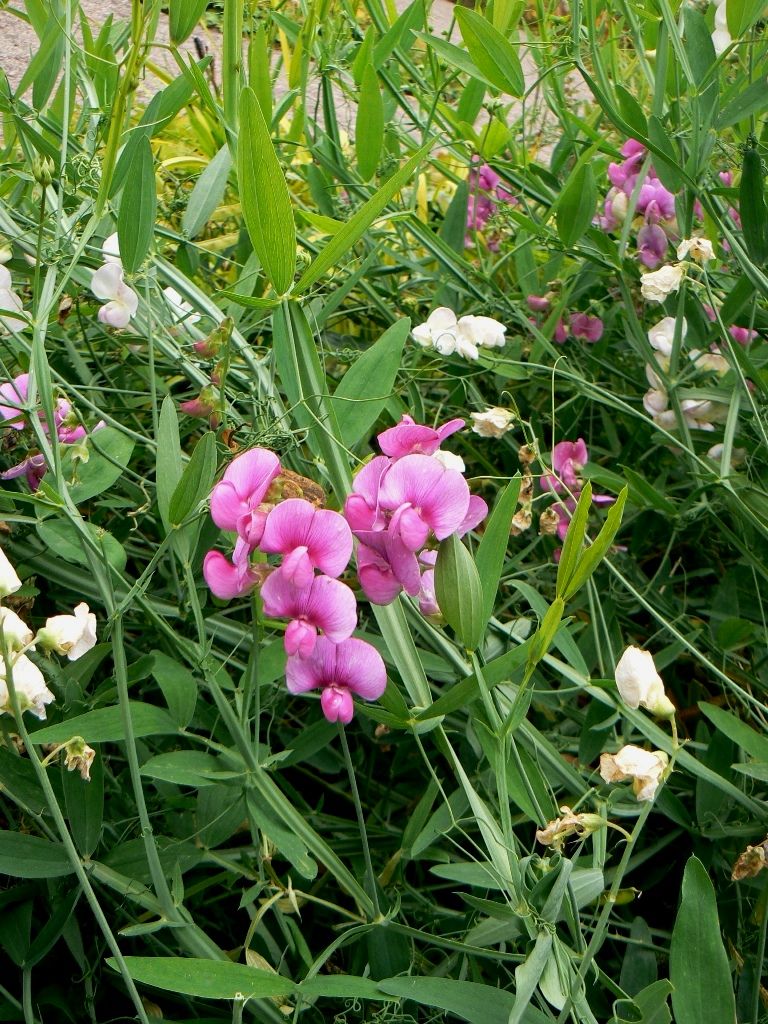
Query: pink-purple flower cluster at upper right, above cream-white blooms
598 138 677 270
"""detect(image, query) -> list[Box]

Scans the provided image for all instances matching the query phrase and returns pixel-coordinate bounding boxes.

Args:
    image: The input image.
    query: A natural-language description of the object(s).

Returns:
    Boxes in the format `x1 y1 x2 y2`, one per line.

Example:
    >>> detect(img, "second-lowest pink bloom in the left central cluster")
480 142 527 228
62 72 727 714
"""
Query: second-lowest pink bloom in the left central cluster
261 572 357 657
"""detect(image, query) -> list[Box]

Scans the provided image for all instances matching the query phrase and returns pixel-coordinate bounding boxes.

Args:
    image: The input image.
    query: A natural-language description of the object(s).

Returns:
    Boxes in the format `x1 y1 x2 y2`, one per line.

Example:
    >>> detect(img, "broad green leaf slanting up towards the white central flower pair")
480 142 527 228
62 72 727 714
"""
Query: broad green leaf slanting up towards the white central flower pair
331 317 411 447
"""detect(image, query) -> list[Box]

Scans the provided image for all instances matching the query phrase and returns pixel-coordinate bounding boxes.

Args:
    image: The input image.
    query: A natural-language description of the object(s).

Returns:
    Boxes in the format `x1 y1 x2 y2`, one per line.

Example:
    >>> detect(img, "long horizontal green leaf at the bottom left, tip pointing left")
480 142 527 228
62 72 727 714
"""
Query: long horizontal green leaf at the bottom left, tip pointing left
106 956 294 999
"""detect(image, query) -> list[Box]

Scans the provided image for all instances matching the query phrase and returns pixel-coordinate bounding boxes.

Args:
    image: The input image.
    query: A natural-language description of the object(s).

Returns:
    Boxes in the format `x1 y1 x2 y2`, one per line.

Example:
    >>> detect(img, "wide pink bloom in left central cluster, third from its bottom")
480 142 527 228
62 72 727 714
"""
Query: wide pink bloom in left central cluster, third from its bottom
260 498 352 587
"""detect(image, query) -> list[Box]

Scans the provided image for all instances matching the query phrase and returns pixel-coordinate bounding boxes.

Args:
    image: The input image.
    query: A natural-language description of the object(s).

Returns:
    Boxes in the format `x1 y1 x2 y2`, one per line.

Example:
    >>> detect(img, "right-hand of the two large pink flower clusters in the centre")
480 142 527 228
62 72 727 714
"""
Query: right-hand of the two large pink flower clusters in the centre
344 416 488 614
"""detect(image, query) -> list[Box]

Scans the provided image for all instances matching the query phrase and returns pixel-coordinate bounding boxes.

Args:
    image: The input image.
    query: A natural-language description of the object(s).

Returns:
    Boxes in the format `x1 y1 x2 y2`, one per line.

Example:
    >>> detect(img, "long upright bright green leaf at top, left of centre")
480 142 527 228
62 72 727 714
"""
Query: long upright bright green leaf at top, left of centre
238 88 296 295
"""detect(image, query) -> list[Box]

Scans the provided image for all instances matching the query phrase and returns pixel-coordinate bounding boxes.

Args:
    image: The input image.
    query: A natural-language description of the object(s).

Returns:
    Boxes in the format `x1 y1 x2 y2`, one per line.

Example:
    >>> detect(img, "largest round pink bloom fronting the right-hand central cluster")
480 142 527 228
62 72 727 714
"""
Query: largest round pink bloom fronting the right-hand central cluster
379 455 469 551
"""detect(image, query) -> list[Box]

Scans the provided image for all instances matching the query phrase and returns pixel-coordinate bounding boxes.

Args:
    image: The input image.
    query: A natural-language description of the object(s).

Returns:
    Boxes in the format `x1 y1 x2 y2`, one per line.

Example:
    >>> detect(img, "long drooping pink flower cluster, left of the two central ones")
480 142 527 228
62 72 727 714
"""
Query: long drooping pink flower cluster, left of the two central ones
203 447 386 723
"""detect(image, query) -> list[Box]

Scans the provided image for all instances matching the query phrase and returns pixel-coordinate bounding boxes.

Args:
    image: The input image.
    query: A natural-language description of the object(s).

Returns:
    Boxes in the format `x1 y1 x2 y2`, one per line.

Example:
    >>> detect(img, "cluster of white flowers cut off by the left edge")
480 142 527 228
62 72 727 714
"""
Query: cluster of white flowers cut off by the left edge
0 549 96 719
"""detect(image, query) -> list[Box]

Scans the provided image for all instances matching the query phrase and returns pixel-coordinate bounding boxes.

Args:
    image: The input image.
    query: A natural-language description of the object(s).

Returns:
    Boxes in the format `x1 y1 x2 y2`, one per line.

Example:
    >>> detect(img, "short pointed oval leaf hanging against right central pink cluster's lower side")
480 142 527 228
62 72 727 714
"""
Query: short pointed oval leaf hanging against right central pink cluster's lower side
434 534 485 650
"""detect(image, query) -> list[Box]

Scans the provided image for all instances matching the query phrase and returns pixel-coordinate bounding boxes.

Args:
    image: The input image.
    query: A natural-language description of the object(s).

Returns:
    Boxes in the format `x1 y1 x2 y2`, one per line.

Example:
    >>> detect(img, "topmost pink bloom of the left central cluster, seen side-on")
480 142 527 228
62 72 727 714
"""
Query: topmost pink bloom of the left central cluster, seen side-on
211 447 280 561
